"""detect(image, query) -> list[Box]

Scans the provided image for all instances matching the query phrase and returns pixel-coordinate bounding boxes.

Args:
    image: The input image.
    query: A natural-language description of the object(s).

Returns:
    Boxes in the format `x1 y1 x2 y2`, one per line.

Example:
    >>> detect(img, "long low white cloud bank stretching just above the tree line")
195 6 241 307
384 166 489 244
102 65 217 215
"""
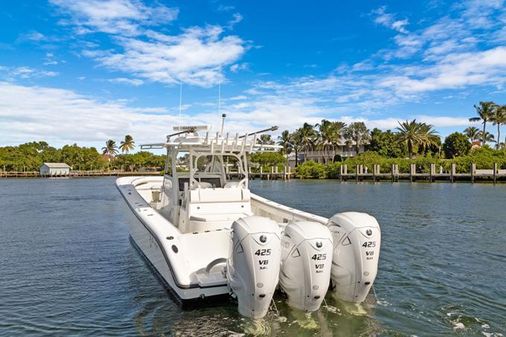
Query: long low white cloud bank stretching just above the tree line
0 82 478 148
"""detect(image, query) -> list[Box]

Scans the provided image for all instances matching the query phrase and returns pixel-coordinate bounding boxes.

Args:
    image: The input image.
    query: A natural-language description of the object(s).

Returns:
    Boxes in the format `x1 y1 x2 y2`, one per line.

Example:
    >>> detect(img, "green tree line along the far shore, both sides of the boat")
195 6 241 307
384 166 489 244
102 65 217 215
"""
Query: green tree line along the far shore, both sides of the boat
0 101 506 171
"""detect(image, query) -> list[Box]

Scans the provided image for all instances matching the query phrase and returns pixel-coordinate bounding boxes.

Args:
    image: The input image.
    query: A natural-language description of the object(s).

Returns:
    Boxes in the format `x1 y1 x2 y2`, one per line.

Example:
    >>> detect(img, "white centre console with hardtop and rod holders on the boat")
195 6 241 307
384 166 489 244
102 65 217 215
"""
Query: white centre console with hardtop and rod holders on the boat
138 126 279 233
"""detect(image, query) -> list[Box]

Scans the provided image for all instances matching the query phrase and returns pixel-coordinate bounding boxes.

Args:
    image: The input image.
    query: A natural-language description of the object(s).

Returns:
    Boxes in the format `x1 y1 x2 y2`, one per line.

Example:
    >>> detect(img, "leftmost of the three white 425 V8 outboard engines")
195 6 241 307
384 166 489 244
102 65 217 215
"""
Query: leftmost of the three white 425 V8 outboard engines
227 216 281 319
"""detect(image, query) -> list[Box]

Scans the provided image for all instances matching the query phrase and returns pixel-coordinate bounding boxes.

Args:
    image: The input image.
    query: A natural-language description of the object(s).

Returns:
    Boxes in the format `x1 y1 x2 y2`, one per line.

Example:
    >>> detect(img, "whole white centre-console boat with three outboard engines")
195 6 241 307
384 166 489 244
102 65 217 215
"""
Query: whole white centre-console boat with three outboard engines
116 127 381 318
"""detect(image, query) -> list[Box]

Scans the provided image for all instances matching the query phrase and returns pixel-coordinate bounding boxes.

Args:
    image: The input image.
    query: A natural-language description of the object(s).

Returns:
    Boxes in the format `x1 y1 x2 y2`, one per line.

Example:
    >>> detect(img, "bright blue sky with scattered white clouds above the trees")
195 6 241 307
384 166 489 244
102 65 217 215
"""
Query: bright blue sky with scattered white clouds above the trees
0 0 506 148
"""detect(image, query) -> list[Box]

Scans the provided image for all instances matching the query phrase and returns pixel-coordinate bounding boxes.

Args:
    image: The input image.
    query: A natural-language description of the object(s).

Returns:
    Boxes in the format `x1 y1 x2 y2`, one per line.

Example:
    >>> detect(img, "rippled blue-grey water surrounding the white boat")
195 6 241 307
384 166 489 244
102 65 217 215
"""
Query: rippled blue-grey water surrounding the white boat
0 178 506 336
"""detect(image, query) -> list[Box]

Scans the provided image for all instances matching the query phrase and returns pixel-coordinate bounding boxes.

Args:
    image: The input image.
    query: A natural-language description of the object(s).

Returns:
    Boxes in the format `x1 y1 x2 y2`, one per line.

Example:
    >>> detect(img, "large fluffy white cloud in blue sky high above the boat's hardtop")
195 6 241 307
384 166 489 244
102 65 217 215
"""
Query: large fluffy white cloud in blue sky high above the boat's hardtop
85 26 246 87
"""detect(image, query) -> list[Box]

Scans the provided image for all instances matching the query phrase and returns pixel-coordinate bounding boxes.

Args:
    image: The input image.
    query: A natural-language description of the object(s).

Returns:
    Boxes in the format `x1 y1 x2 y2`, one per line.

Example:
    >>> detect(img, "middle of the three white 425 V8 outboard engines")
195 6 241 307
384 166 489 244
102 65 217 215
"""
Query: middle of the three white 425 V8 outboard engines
279 221 333 311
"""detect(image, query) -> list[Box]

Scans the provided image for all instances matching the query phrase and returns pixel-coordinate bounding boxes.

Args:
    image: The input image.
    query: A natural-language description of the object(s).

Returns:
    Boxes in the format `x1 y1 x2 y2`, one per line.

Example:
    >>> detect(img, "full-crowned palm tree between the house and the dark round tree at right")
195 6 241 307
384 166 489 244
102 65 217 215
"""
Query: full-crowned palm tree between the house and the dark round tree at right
397 119 439 159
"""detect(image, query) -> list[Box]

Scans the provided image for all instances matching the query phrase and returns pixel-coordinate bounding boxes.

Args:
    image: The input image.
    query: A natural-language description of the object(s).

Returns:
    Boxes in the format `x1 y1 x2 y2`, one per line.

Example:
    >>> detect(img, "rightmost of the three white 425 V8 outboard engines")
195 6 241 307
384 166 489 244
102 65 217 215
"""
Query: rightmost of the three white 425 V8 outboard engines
328 212 381 303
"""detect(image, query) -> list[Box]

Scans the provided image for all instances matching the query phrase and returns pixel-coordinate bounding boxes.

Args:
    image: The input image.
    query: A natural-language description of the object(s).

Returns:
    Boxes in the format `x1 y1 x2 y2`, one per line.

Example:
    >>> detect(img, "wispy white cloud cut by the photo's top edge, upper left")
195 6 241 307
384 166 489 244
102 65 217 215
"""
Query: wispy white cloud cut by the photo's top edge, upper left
50 0 178 35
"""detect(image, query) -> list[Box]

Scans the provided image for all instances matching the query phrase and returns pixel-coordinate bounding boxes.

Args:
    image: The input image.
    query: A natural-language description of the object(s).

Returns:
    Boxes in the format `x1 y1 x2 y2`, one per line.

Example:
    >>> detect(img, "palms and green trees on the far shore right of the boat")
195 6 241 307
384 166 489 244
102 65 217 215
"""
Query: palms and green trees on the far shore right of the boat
259 102 506 164
